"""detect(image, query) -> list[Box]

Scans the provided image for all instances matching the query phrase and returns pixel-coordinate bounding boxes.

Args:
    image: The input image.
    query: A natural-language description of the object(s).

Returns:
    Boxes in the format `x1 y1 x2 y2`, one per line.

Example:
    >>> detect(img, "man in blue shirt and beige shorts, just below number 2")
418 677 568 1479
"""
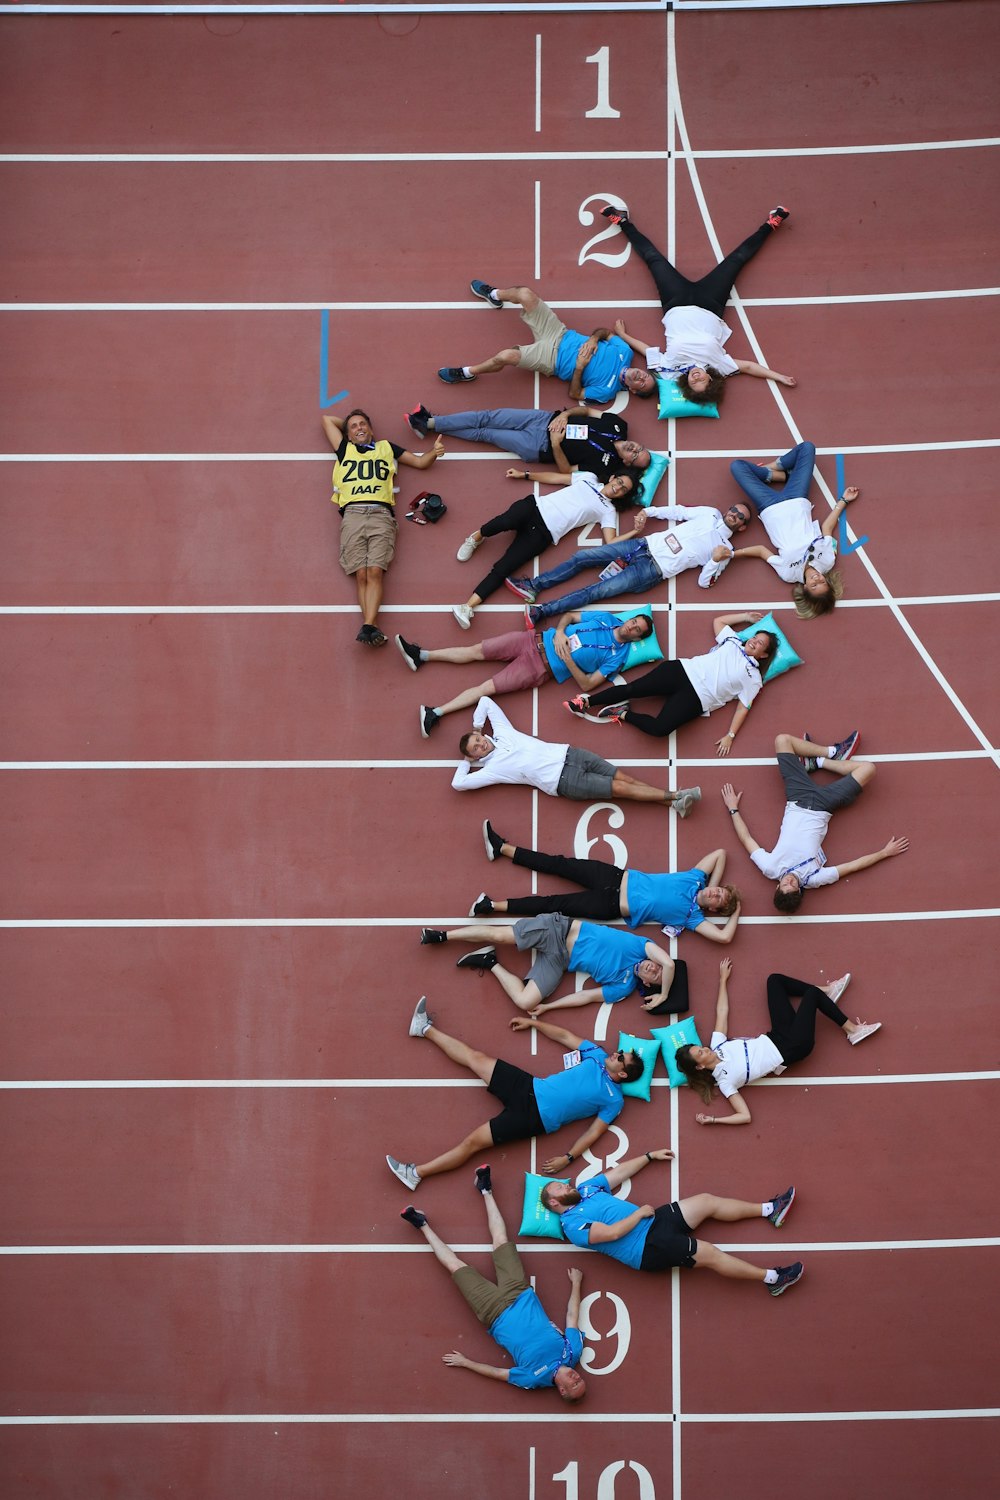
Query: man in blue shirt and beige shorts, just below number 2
438 281 633 402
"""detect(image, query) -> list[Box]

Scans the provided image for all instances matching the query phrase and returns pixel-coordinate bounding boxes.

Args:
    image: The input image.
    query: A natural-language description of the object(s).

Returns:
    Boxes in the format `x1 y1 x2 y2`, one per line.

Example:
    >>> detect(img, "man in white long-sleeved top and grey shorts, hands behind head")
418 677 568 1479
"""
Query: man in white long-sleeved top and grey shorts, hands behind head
451 698 702 818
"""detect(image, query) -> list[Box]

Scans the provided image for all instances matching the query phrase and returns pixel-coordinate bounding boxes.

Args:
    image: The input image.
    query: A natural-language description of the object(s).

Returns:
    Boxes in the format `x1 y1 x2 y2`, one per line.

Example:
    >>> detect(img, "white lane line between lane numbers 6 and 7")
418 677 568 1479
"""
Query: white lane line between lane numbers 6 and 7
0 906 1000 932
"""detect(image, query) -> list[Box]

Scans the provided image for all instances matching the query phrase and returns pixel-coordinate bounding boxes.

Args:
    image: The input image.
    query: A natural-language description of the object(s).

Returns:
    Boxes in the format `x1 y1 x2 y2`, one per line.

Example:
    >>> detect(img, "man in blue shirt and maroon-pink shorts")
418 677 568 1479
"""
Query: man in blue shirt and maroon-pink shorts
396 609 652 740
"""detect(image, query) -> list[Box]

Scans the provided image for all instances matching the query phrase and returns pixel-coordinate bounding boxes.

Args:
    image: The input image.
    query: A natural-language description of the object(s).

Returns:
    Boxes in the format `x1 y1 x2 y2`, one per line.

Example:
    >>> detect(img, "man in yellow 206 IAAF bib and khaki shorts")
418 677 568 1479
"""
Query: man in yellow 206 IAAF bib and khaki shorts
322 410 444 647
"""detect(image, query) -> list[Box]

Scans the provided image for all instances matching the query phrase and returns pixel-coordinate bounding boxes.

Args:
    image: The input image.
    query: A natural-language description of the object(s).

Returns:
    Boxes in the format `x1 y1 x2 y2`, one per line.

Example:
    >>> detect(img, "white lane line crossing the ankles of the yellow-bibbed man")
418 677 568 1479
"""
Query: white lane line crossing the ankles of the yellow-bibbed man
0 594 1000 612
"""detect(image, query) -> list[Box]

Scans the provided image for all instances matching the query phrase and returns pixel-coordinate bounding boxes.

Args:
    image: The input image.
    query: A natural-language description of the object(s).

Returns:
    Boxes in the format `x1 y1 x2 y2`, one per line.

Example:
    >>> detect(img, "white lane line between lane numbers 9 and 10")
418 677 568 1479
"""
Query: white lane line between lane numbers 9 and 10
0 1407 1000 1428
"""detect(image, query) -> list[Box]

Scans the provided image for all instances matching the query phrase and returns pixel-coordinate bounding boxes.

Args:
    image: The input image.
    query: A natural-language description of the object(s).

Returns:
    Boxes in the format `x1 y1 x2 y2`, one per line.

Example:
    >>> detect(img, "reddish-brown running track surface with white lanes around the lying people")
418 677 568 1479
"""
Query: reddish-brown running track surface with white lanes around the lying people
0 0 1000 1500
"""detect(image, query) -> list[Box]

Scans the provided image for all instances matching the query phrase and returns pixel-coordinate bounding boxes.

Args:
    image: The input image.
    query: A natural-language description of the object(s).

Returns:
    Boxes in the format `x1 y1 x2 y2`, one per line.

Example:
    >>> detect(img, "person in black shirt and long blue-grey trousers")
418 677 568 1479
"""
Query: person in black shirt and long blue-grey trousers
406 407 649 483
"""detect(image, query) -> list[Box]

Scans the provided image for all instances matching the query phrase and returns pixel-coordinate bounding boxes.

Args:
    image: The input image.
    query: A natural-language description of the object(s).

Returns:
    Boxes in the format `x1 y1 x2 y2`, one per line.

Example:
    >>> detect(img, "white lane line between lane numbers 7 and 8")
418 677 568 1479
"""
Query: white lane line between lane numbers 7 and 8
0 1070 1000 1094
